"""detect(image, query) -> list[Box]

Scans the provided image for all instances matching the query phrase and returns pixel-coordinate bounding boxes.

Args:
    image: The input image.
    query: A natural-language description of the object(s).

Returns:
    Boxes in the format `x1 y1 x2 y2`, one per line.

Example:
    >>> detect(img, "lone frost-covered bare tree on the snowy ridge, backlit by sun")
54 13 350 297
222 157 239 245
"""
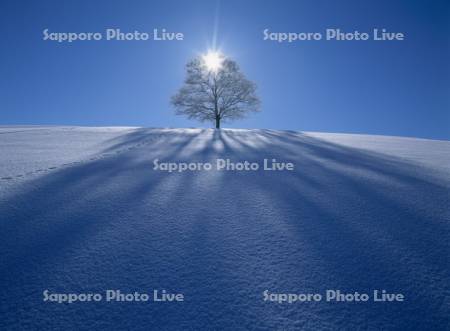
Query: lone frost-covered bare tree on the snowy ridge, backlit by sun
172 58 260 129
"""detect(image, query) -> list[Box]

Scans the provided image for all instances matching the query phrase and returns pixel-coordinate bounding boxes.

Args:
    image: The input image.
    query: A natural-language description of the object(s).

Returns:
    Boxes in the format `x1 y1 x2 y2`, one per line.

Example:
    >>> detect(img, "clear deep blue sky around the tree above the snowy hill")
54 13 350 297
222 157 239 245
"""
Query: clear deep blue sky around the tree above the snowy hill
0 0 450 139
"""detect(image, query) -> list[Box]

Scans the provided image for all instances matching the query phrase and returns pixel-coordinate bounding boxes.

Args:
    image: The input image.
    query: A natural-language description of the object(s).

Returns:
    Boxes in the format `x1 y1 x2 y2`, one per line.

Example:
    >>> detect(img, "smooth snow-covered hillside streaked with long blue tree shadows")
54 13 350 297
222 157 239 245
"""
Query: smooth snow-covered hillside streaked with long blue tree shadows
0 127 450 330
